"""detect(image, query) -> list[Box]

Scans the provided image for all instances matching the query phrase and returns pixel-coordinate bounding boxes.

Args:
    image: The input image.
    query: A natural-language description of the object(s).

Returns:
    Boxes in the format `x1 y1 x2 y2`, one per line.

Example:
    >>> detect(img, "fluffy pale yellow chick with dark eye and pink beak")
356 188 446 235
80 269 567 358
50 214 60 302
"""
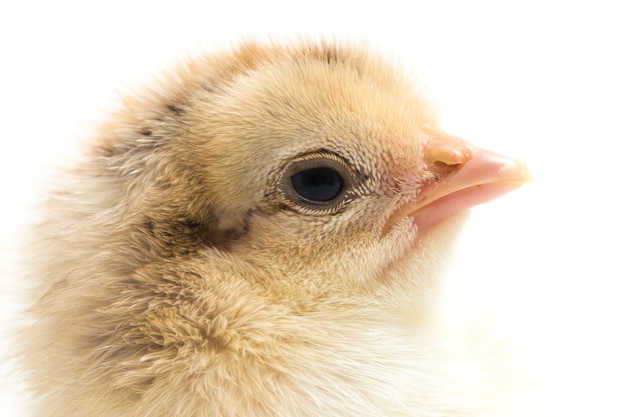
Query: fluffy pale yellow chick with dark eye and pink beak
22 42 529 417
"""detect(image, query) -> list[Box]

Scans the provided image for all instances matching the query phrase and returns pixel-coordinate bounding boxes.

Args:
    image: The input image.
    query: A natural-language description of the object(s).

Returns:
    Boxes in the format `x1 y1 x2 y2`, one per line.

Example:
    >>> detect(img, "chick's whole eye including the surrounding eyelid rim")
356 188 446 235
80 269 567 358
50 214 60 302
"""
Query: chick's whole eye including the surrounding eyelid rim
281 153 354 213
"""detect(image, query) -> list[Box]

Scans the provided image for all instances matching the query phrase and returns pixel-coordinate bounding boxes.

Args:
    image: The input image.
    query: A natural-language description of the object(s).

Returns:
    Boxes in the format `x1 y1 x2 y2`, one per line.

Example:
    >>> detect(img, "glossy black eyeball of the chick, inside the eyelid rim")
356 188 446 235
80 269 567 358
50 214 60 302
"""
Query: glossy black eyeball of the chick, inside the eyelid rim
291 167 343 201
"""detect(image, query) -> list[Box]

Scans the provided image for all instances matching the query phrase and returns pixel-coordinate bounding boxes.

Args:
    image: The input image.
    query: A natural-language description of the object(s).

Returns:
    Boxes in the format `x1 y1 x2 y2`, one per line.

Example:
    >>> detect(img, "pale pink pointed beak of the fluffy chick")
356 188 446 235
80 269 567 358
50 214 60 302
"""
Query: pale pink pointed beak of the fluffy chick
402 135 532 231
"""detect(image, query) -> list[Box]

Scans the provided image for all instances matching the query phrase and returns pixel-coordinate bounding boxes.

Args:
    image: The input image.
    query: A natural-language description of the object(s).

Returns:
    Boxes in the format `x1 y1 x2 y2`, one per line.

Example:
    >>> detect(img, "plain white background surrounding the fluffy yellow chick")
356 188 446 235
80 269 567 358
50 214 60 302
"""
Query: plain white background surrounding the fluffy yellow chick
0 0 626 417
